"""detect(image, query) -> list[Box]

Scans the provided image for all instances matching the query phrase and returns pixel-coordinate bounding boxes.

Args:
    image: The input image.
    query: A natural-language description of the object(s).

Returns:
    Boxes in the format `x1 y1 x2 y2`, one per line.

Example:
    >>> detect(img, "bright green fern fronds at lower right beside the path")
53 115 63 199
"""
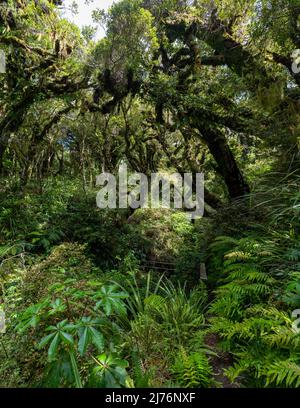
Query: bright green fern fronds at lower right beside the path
209 231 300 387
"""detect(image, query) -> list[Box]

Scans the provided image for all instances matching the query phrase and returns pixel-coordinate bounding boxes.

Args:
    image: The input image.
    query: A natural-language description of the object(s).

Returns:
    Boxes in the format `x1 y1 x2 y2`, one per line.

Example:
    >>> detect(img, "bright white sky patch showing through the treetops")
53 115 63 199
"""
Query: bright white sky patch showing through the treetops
64 0 116 39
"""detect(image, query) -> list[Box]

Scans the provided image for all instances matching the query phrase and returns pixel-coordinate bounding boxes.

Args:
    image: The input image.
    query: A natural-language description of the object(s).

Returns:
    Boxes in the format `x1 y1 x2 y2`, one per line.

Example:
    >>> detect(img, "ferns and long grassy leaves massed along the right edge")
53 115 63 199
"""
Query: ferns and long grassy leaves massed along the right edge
209 175 300 387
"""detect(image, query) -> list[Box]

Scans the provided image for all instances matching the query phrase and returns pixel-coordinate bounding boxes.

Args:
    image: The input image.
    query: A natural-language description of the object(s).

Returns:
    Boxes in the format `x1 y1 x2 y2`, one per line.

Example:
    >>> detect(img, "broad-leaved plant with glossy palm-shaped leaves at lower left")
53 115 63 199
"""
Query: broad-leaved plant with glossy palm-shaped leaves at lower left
16 264 127 388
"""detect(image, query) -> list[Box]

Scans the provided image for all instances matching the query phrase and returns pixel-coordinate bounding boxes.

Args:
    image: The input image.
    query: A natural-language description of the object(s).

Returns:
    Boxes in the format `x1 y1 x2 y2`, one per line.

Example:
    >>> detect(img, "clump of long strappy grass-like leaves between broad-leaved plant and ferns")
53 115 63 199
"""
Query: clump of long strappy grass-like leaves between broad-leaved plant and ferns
120 275 210 386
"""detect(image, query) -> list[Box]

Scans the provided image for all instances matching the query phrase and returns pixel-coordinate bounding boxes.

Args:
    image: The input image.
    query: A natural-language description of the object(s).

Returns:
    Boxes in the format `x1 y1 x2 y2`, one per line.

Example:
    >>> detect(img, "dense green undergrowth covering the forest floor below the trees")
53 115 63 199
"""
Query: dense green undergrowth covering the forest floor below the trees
0 174 300 387
